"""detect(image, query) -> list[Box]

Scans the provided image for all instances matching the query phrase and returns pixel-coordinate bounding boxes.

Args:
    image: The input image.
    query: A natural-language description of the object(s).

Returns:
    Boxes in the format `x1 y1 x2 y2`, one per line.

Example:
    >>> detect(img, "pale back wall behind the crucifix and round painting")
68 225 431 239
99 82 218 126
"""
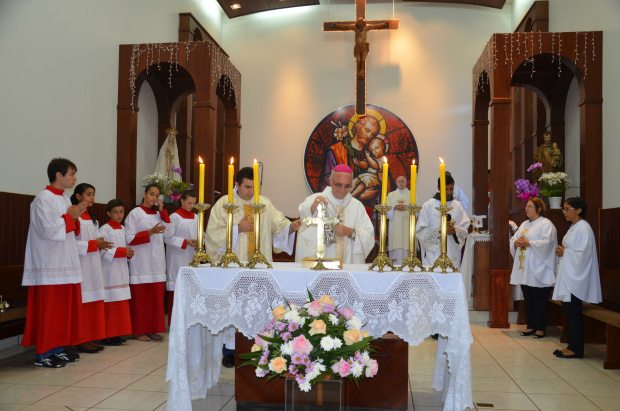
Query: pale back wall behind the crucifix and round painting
224 3 510 216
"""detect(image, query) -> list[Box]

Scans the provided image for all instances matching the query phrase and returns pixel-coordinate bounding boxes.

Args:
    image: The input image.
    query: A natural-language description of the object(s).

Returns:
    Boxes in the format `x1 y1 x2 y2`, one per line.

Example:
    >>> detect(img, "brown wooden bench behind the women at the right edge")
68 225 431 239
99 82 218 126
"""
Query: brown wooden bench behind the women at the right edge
549 294 620 370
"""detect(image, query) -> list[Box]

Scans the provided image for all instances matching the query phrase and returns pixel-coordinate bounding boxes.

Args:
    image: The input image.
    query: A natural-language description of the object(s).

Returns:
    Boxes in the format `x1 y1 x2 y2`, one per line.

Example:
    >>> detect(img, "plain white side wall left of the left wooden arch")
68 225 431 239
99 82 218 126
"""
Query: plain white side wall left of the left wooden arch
0 0 223 203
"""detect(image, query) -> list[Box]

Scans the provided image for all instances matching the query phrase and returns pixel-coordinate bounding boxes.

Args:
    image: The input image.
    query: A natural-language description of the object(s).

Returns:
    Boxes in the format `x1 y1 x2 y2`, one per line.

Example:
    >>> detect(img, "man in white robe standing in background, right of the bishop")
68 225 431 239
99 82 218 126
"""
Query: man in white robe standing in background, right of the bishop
386 176 411 265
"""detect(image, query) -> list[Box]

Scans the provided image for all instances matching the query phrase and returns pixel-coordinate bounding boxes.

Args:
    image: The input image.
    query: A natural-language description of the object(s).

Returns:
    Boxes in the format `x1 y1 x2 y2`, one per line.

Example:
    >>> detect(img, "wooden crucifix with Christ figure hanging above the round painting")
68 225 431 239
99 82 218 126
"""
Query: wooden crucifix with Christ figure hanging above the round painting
323 0 398 116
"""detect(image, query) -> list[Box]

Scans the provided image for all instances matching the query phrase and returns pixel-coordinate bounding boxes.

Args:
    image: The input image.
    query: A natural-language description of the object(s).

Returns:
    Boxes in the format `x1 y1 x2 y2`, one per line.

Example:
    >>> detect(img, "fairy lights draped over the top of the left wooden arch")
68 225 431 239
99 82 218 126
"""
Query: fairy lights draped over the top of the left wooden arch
129 40 241 110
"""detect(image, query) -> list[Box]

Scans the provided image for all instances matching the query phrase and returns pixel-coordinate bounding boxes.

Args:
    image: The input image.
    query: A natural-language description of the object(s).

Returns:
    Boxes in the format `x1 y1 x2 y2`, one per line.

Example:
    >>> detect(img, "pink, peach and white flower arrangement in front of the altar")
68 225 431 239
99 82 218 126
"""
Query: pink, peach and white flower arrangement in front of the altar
239 293 379 392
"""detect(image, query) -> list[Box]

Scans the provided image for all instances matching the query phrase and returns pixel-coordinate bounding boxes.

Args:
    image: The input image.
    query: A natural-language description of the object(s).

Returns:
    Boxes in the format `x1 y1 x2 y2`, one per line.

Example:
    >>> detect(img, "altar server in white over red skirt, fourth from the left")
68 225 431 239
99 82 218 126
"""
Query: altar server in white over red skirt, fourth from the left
125 184 170 341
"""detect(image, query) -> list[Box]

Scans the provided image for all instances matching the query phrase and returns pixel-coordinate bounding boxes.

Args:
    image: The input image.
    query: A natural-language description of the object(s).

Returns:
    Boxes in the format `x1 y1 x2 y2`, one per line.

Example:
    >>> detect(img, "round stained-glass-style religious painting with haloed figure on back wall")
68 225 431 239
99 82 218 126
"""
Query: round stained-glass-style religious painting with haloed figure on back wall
304 104 420 206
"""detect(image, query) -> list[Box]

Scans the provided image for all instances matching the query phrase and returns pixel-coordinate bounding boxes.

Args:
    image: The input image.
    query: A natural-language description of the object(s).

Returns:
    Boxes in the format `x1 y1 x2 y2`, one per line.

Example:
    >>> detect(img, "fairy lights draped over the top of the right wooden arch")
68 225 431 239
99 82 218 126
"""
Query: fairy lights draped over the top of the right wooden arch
472 31 596 93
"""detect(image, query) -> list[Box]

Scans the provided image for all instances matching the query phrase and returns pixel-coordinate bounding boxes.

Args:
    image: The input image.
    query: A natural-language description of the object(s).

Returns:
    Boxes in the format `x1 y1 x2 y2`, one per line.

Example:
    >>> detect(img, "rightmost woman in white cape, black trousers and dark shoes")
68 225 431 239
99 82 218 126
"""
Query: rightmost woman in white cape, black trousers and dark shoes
552 197 602 358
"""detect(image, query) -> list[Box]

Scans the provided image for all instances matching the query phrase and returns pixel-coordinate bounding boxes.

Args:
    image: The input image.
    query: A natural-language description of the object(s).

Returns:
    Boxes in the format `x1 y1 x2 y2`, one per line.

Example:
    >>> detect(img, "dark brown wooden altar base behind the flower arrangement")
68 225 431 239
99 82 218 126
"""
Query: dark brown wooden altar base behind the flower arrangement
235 333 409 411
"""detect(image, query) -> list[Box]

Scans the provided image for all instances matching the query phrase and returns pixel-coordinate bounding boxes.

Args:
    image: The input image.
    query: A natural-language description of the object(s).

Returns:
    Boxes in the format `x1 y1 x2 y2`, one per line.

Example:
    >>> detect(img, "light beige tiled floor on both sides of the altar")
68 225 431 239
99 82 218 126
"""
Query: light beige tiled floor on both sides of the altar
0 323 620 411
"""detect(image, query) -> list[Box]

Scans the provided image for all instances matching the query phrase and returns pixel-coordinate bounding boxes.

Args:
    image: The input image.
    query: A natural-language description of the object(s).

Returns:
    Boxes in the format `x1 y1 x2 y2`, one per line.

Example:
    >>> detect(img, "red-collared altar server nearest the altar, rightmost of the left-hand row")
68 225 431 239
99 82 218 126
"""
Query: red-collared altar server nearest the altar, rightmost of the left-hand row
164 190 198 326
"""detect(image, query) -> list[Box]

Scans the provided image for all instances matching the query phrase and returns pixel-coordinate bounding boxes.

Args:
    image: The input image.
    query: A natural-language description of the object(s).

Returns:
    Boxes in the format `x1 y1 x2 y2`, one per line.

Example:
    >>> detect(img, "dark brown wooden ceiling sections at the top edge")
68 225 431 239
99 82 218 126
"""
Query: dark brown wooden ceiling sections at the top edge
217 0 506 19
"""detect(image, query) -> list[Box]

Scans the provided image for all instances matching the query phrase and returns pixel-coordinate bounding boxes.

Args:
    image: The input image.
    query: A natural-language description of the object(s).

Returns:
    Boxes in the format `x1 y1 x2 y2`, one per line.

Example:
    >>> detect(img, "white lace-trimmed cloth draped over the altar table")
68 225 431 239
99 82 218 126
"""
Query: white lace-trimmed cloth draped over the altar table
166 263 474 411
